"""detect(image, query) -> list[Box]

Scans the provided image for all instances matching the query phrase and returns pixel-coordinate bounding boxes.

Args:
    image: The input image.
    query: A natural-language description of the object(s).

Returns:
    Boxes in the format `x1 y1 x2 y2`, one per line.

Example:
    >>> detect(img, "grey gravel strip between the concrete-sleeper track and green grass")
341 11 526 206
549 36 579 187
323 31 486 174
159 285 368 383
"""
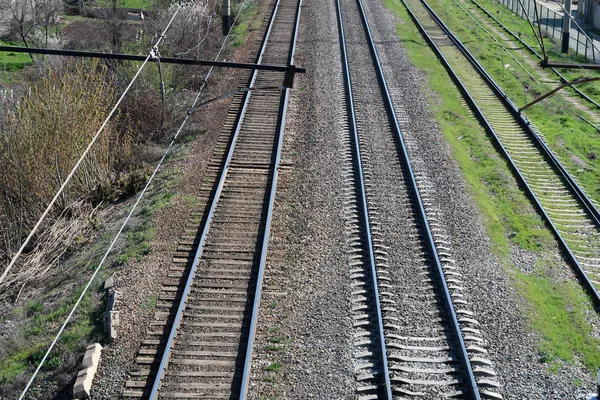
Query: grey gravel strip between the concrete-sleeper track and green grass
363 1 598 400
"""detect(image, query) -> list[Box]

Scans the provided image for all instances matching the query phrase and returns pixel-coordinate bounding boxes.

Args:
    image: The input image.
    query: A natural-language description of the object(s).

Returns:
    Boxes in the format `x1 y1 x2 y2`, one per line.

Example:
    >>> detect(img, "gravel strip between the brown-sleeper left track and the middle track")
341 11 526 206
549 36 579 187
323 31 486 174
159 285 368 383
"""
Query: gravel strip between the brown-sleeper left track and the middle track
249 0 355 399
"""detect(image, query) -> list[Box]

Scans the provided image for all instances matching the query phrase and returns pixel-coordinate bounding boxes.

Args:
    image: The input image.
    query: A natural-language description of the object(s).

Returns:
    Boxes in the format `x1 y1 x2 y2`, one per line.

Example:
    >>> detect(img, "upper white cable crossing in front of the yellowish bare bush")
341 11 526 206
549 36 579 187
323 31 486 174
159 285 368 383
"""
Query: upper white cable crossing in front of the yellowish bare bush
0 8 179 284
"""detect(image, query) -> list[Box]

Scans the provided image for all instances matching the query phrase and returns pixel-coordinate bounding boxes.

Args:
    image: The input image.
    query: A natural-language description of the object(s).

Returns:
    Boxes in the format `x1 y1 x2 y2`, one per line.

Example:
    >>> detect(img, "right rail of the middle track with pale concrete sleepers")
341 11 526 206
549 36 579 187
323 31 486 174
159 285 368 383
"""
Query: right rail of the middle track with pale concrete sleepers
344 0 481 400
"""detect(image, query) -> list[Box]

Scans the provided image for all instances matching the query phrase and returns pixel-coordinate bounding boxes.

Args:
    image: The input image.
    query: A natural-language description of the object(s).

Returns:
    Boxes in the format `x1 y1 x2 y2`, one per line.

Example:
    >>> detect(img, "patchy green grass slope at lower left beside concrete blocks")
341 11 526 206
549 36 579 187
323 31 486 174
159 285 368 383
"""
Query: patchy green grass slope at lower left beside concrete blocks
0 170 180 394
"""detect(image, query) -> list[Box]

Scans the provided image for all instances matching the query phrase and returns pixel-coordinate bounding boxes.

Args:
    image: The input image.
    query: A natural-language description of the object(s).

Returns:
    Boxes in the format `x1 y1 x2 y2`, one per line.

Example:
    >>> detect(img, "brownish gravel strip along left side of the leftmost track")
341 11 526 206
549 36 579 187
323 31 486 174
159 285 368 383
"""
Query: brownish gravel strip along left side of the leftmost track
91 12 269 399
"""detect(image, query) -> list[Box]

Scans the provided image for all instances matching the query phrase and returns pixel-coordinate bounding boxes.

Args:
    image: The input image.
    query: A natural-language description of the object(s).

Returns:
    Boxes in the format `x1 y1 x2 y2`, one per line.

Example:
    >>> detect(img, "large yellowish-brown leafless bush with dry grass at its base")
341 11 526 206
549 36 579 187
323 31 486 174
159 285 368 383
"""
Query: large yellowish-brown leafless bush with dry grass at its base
0 58 132 290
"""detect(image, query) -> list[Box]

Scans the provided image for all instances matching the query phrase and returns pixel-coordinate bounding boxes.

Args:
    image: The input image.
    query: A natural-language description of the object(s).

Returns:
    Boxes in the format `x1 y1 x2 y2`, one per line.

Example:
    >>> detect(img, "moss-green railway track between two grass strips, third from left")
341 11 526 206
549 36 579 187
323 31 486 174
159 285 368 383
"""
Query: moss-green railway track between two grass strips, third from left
402 0 600 305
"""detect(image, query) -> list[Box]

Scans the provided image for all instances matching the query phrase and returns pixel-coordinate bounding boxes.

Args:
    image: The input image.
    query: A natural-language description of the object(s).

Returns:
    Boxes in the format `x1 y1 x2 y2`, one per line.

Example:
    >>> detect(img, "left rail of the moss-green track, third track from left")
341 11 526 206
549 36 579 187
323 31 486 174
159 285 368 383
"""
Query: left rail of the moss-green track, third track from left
401 0 600 306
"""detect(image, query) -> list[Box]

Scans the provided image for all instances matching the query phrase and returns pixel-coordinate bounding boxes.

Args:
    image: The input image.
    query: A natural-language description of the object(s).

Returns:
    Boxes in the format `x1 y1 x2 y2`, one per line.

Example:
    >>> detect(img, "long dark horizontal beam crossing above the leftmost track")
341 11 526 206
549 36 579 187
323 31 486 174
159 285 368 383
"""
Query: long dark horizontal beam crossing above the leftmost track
0 46 306 73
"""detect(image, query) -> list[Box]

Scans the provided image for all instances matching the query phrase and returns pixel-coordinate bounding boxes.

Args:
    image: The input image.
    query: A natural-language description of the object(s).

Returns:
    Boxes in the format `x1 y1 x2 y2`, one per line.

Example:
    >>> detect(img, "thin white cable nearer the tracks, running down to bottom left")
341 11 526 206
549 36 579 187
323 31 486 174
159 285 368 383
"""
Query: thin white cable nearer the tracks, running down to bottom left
19 0 247 400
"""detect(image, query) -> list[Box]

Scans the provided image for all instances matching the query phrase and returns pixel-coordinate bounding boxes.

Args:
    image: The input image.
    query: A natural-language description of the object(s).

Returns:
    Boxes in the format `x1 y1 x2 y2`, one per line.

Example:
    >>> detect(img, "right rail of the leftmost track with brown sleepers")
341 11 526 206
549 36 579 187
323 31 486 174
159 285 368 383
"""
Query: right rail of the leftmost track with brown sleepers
240 0 302 399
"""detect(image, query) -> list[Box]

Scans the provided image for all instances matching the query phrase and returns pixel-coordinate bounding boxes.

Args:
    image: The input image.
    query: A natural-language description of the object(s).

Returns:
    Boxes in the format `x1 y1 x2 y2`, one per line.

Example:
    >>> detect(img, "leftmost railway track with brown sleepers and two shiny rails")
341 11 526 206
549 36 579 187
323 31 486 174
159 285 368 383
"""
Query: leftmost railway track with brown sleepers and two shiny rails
122 0 301 399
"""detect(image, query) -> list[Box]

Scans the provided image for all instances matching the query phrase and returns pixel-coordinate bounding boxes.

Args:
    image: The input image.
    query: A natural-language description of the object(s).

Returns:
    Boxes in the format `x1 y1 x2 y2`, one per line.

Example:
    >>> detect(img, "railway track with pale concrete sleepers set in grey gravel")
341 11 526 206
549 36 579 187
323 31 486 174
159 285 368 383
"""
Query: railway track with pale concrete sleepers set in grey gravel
337 0 502 400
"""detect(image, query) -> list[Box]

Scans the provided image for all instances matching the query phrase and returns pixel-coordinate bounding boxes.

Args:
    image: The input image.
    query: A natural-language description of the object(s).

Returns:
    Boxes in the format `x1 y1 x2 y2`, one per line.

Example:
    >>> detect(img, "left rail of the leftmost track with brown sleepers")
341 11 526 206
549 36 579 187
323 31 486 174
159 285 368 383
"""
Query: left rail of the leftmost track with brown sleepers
149 0 280 400
